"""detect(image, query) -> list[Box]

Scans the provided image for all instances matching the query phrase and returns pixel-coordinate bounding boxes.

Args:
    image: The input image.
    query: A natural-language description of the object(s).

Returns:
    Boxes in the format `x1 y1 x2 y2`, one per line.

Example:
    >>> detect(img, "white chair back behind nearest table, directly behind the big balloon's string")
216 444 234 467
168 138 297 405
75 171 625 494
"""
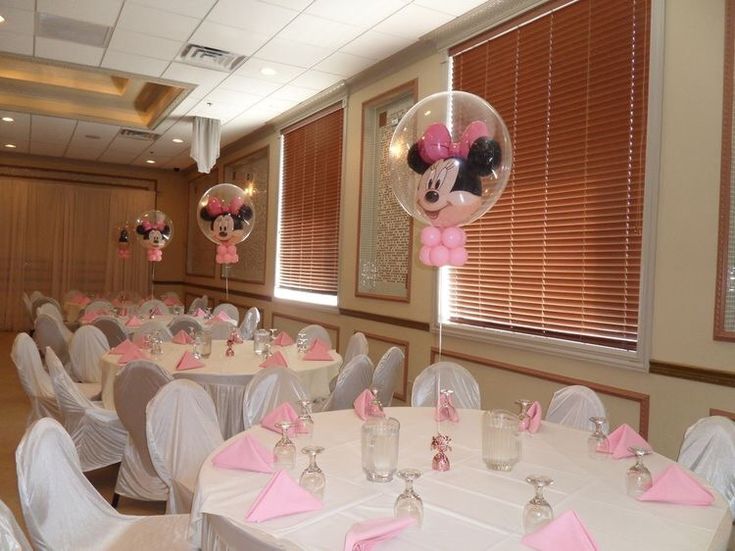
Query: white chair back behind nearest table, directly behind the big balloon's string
411 362 481 409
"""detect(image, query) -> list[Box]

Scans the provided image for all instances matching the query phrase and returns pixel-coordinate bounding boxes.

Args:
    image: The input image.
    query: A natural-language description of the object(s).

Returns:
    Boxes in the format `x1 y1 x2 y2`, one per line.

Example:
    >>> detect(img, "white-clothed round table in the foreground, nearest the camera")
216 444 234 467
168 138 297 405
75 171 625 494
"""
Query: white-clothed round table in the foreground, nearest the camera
190 407 732 551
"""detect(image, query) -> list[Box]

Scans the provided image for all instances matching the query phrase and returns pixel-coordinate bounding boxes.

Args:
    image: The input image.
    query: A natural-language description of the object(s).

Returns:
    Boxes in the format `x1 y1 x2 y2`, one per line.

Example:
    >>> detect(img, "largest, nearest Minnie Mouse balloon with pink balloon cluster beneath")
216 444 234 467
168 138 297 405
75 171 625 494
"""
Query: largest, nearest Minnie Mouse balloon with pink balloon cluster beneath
389 92 513 266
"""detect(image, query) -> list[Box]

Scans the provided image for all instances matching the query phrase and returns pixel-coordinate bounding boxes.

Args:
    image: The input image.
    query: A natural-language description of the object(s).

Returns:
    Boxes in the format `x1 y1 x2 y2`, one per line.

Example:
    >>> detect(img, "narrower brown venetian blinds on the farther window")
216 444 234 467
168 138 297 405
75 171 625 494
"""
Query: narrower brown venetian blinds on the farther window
279 105 343 295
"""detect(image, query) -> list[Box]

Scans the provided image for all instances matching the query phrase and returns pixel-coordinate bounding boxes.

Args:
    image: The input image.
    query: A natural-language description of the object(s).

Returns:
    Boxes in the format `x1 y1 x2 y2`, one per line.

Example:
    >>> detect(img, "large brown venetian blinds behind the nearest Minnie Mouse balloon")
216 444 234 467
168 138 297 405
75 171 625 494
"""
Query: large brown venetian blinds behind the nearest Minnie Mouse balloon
450 0 650 349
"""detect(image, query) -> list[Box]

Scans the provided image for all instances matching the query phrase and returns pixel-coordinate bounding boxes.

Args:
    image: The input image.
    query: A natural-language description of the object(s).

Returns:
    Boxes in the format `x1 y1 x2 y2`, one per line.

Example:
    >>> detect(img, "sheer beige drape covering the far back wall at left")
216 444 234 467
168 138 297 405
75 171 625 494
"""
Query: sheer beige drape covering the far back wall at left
0 176 155 330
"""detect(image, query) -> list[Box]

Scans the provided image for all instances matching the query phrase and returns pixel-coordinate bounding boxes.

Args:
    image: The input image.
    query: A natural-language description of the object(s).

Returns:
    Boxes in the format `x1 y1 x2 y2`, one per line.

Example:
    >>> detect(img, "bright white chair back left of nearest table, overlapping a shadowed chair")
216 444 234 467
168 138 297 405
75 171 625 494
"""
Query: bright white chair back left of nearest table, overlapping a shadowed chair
145 379 223 514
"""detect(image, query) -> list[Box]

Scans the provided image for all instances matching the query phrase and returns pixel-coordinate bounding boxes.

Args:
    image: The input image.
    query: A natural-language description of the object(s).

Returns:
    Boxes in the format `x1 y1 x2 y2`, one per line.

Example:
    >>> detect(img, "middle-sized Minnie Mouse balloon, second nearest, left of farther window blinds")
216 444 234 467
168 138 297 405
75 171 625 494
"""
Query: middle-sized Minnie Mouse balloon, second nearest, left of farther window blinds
197 184 255 264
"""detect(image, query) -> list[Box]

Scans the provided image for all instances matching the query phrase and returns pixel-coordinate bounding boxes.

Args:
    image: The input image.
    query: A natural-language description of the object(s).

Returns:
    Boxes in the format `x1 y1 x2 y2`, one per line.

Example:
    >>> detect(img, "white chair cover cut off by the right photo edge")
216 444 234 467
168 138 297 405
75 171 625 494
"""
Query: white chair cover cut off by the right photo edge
677 416 735 517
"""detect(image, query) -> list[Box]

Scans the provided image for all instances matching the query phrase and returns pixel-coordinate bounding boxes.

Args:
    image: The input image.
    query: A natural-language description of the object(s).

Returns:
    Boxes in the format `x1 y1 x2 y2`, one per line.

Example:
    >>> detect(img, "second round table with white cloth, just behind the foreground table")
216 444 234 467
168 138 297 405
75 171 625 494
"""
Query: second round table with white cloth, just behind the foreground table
100 340 342 438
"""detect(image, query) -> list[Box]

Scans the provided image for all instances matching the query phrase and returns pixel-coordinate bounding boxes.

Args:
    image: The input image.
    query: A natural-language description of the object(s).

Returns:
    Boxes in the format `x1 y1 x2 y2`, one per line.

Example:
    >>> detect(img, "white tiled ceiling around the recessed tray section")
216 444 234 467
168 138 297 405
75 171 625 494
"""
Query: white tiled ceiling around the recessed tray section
0 0 492 168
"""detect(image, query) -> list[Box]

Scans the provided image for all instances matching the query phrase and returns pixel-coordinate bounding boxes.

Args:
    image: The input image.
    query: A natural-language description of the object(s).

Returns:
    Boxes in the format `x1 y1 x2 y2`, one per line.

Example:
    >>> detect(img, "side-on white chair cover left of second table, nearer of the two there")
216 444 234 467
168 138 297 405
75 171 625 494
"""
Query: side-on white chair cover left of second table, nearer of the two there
46 348 128 472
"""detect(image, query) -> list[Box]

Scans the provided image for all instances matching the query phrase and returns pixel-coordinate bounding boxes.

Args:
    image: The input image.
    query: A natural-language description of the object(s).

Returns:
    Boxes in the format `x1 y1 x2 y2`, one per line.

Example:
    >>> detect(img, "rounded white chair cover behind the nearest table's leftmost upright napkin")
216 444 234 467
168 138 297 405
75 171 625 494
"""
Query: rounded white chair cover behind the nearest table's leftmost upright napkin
242 367 310 429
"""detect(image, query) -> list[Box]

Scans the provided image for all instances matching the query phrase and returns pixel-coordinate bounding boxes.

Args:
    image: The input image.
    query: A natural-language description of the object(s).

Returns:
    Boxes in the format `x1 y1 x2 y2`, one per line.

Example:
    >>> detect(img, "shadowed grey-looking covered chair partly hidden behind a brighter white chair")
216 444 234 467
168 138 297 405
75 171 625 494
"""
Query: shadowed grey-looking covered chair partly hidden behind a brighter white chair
113 360 173 506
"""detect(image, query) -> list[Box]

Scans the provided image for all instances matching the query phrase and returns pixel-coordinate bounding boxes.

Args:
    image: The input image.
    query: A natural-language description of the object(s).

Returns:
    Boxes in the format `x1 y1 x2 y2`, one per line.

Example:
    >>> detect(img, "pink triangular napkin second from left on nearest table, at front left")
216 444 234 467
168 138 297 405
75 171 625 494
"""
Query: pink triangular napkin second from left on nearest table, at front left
245 470 322 522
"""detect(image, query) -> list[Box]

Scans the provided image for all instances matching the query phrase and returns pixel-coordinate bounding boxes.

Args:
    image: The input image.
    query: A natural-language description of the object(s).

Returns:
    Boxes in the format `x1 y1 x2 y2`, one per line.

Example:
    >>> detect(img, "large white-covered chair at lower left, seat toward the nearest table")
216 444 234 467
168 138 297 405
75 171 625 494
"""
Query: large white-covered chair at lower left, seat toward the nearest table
15 419 191 551
